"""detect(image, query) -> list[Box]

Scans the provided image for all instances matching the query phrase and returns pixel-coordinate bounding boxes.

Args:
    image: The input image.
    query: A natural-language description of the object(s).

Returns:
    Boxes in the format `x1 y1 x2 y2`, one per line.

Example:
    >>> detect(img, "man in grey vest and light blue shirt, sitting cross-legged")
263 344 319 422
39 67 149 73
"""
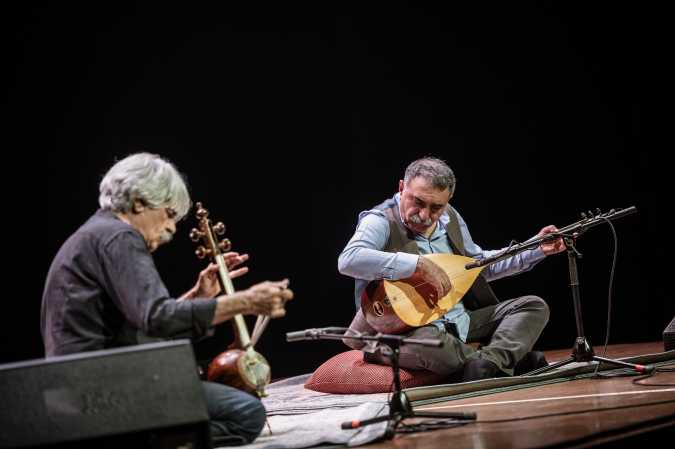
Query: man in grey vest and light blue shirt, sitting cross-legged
338 157 565 381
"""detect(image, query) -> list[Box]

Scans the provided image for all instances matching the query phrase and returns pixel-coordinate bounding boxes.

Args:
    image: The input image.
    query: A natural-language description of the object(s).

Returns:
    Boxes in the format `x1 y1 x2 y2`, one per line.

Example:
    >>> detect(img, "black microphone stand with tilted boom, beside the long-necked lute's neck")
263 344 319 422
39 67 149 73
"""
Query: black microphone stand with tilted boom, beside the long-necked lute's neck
465 206 654 376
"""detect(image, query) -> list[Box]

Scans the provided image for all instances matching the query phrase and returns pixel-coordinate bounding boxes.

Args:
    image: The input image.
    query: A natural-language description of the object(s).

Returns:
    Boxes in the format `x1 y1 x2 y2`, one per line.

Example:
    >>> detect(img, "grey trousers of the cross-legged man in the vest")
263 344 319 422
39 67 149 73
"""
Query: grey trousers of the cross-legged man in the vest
356 296 549 375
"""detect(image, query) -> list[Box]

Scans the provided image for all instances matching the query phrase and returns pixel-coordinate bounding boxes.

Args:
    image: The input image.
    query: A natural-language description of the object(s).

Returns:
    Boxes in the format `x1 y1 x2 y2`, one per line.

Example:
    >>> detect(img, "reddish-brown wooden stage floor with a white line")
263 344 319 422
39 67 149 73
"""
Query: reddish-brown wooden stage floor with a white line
367 342 675 449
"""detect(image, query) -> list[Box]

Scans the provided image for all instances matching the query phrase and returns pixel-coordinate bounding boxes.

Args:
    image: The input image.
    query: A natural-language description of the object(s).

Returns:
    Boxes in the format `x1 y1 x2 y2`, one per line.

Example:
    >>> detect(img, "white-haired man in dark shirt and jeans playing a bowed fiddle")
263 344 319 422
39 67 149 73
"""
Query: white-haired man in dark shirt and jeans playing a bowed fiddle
41 153 293 446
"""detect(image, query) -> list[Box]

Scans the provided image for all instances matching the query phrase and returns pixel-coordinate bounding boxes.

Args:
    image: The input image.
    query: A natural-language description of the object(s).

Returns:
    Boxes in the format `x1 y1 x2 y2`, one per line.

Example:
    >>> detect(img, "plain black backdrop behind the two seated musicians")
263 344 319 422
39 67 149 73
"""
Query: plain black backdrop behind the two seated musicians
5 2 675 378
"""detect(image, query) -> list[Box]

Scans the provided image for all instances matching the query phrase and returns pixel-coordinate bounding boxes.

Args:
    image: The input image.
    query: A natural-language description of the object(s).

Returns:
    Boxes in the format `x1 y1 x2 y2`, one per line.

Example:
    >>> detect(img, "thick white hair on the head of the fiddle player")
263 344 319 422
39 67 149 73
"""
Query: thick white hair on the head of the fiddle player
98 153 190 220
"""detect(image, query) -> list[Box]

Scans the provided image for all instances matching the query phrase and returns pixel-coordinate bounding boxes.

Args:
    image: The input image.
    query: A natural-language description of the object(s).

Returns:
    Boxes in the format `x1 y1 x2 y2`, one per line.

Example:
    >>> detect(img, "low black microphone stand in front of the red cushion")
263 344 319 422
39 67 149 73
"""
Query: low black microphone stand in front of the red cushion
286 327 476 438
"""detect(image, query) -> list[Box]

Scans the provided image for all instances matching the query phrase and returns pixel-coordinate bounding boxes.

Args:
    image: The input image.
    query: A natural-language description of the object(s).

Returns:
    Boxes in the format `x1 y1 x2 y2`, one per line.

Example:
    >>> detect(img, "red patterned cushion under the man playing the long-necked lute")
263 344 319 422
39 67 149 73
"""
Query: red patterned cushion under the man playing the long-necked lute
305 350 443 394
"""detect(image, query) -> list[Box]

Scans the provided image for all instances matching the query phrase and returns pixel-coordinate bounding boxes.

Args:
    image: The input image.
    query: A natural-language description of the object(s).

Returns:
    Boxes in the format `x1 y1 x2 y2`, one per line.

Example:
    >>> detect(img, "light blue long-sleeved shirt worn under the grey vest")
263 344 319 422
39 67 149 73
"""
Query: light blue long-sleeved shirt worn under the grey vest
338 193 546 341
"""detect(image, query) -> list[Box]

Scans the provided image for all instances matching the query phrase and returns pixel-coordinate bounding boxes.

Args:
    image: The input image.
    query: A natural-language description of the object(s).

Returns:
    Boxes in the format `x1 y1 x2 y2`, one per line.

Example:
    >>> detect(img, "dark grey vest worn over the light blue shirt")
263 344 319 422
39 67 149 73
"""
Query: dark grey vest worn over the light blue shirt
374 198 499 310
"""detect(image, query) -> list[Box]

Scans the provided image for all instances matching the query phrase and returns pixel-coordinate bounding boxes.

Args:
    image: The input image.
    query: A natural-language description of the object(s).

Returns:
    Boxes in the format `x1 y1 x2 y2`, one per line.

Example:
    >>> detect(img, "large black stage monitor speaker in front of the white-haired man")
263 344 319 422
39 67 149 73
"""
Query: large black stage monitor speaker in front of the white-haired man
0 340 211 449
